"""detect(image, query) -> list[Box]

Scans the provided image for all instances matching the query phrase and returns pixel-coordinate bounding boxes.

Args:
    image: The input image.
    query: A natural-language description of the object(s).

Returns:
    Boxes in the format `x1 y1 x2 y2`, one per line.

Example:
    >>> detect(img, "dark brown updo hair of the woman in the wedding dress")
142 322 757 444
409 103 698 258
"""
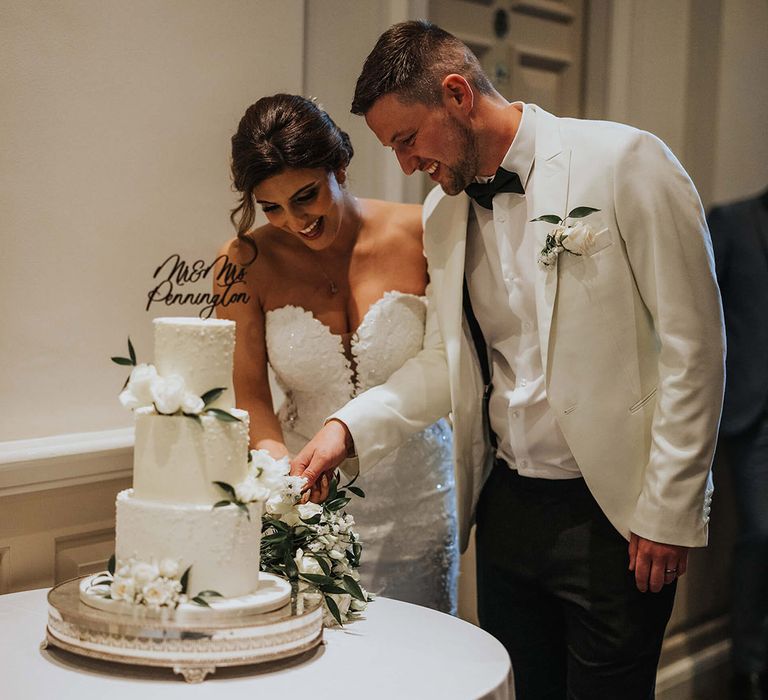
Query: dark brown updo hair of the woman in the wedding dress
229 93 354 254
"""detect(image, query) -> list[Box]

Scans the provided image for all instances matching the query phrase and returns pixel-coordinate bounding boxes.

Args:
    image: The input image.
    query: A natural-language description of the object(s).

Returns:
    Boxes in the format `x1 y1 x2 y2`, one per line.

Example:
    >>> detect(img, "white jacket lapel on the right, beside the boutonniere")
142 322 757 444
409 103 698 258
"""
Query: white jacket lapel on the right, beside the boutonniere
525 107 571 377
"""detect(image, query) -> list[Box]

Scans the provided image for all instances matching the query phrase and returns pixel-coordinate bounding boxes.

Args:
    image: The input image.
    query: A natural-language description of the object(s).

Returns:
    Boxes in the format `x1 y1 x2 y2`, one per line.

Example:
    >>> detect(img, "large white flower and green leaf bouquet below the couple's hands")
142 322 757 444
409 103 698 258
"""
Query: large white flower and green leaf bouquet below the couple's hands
214 450 372 625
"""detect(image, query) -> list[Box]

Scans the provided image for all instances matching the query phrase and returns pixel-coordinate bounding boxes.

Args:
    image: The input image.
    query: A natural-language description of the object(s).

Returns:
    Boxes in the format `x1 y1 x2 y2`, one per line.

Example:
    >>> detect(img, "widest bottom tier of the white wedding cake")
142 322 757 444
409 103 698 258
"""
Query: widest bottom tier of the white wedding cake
115 489 262 598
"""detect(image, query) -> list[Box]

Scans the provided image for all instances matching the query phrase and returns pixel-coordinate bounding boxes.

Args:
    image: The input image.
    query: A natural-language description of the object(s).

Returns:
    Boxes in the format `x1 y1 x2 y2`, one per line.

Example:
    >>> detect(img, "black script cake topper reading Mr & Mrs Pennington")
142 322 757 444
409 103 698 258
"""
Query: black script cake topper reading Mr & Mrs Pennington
145 253 250 318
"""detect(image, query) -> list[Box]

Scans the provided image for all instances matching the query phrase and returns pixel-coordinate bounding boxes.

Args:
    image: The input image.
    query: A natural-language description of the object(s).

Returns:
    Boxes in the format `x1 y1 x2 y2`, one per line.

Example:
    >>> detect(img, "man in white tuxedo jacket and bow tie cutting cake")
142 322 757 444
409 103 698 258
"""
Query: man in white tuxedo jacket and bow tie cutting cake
293 21 724 700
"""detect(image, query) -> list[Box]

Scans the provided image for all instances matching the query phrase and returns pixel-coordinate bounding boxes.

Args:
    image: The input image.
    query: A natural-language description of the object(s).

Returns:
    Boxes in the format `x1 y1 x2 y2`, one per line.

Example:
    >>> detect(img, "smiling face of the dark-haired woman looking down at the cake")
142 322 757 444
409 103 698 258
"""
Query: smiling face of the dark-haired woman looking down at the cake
253 168 345 250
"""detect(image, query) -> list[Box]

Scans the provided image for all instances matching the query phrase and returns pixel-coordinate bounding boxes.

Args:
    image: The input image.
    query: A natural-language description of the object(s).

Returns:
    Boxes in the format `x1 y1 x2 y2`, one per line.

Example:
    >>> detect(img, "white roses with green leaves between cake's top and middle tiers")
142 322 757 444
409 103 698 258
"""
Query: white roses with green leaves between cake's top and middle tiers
112 338 240 422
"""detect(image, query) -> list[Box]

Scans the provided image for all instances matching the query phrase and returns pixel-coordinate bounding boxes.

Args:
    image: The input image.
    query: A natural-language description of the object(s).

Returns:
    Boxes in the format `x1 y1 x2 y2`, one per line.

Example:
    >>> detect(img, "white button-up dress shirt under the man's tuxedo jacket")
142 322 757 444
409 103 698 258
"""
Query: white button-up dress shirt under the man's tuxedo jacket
465 103 581 479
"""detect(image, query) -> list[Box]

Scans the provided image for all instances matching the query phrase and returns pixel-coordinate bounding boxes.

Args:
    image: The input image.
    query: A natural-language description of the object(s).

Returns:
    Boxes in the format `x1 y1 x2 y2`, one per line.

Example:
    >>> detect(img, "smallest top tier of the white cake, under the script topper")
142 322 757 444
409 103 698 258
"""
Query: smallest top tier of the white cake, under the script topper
154 318 235 410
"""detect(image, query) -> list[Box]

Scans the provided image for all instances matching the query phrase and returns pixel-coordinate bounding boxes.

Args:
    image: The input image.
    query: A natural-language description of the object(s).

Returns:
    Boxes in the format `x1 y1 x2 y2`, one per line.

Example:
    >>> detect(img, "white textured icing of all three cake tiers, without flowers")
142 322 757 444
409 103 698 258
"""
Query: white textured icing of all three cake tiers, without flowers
115 318 262 598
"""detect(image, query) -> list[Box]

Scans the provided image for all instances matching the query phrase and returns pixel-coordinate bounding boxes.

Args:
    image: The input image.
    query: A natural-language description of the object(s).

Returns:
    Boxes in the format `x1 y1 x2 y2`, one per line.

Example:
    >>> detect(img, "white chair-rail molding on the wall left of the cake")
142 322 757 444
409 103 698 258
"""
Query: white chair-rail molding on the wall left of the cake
0 428 133 497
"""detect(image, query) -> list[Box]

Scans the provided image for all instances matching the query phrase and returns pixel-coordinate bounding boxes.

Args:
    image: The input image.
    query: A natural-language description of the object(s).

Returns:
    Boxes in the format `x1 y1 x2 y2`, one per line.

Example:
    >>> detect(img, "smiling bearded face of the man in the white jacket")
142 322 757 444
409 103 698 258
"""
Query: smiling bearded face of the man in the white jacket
365 94 478 195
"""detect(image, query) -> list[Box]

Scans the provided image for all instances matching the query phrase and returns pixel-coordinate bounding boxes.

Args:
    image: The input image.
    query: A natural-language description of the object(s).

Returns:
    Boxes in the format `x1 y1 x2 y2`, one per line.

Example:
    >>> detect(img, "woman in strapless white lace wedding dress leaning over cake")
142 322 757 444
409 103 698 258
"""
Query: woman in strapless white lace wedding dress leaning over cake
213 94 458 613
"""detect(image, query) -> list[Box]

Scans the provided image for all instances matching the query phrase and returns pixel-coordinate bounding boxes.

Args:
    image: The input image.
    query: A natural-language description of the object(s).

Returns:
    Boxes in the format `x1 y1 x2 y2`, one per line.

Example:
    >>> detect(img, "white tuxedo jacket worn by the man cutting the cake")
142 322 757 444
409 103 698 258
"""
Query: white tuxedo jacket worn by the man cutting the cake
334 105 725 549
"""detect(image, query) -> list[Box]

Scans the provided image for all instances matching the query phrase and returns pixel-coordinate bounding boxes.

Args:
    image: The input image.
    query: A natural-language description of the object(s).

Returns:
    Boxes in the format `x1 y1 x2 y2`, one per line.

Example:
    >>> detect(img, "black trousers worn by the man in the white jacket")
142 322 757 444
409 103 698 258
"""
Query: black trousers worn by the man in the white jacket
477 462 675 700
